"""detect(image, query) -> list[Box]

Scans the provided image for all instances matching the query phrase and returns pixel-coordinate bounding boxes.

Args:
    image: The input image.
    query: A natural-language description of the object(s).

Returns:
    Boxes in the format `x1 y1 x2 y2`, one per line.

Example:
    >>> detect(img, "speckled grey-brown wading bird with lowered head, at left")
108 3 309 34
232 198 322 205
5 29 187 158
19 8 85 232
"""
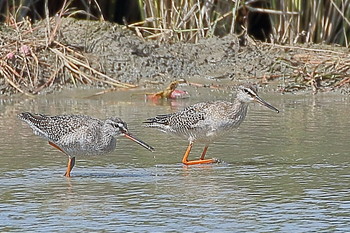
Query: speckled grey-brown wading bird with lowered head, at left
18 112 153 177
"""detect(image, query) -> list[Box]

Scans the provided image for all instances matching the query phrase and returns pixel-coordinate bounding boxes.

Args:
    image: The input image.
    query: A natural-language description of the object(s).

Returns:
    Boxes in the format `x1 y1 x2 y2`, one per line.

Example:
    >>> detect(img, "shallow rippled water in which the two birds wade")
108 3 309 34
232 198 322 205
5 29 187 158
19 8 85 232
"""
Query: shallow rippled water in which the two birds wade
0 86 350 232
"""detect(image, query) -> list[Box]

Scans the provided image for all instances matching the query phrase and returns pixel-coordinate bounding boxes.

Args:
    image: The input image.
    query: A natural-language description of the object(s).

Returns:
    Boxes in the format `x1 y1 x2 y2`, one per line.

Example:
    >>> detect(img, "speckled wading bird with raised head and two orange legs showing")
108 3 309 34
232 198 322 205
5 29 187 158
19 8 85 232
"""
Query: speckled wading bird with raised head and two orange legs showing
144 84 279 165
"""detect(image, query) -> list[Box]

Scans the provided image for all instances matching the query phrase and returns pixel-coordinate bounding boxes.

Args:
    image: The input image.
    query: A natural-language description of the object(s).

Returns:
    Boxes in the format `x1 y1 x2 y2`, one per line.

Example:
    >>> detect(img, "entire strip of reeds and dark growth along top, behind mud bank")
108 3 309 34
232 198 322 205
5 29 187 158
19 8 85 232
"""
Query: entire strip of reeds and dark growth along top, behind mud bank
0 0 350 47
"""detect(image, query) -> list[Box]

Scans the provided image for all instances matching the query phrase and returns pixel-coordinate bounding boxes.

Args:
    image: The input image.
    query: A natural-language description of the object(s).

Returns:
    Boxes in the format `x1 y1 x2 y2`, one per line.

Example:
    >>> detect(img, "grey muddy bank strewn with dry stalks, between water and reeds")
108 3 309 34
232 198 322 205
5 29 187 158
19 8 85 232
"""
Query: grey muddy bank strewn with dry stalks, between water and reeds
0 19 350 95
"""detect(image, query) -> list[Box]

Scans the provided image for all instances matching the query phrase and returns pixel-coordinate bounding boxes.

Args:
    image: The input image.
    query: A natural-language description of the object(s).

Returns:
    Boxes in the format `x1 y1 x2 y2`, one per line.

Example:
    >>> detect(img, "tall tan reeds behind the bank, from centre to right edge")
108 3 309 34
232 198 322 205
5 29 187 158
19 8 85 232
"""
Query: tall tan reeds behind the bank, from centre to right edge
133 0 350 47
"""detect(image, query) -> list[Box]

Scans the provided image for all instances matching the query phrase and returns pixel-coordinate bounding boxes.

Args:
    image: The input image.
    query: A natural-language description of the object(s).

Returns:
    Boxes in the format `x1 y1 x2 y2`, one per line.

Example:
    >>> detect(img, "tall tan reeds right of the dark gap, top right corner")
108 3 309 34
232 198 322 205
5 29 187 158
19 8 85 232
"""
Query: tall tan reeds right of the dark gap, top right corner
271 0 350 47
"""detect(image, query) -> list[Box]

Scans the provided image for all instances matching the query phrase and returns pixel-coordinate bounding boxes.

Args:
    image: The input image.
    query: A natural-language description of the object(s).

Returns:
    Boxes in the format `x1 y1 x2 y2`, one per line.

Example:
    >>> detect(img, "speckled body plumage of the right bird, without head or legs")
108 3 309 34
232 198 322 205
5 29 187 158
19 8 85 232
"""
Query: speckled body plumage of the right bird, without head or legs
146 101 248 143
